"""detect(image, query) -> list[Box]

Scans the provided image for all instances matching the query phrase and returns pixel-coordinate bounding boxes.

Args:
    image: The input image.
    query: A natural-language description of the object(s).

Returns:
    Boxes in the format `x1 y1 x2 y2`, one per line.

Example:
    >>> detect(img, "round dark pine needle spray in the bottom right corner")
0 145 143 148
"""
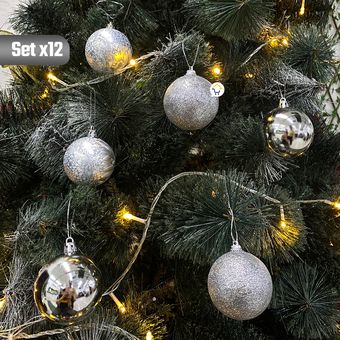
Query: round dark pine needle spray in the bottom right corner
273 263 339 339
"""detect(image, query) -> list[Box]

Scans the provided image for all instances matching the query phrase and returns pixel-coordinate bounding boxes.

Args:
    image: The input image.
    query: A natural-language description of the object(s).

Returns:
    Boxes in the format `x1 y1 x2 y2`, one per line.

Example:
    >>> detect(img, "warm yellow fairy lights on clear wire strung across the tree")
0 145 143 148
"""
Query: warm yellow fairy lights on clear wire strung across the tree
0 0 334 340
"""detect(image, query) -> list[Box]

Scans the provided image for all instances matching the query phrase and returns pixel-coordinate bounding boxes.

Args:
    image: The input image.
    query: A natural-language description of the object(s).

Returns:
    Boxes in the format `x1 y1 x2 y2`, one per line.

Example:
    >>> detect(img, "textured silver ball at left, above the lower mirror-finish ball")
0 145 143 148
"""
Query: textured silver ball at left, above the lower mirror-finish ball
64 137 115 185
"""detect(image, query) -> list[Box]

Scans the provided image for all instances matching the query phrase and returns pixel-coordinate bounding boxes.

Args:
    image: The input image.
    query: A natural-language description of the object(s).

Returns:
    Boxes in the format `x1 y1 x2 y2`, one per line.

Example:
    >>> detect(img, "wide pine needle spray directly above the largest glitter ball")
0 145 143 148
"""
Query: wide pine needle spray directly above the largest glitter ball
143 173 306 266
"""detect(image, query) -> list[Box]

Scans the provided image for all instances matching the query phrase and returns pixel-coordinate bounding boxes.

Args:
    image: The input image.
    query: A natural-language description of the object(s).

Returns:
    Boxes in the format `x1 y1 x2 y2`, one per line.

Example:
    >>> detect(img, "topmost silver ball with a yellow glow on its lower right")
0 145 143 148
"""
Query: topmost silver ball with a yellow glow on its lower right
85 27 132 73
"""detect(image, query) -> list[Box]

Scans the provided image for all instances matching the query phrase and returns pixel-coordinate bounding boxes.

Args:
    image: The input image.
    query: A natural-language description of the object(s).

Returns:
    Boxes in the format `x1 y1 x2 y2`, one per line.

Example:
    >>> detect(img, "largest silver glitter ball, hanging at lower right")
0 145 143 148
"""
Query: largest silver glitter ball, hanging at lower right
208 245 273 320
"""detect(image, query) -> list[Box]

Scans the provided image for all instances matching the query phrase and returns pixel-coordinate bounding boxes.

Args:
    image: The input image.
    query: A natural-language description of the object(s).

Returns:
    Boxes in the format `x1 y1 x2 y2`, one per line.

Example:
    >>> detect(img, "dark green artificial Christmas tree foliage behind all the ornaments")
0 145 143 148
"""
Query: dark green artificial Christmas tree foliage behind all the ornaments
0 0 340 340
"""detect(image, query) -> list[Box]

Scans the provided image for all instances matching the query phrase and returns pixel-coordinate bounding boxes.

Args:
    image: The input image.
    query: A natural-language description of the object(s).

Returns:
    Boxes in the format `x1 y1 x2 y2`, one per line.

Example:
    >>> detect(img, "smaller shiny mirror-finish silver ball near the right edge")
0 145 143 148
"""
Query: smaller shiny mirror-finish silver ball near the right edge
265 107 314 157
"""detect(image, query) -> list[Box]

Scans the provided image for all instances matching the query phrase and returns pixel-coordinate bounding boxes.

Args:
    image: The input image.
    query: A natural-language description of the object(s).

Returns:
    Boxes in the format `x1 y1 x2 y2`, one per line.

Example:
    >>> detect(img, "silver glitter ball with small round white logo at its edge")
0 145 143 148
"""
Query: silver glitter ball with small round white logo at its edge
163 70 219 130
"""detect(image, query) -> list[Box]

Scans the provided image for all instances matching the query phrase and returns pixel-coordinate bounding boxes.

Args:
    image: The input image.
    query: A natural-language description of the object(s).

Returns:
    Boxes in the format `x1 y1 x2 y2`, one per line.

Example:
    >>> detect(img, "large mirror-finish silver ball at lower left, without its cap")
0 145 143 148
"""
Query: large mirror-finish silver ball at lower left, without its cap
34 255 101 324
